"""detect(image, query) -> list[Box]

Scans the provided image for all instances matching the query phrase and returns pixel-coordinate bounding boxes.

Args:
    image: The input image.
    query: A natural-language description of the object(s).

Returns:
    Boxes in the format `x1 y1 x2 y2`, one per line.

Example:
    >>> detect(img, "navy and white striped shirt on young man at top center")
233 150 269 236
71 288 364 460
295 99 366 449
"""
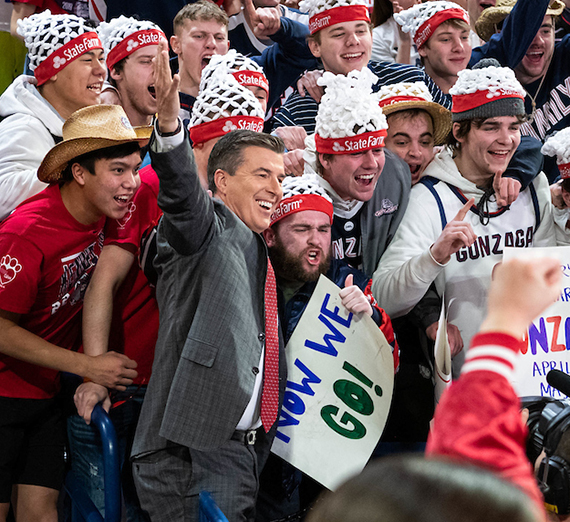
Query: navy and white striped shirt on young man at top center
272 61 451 134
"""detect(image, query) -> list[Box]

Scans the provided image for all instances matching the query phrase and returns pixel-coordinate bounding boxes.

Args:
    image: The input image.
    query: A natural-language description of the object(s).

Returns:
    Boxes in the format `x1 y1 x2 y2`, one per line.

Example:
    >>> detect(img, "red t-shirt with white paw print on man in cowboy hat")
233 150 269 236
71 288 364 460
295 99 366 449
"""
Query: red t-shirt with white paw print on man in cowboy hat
0 185 105 399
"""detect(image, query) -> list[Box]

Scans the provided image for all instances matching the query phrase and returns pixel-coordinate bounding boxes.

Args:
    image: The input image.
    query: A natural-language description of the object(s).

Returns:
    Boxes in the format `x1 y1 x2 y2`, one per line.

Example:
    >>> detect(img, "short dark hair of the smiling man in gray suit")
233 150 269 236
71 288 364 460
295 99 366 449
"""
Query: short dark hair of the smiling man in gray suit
207 130 285 194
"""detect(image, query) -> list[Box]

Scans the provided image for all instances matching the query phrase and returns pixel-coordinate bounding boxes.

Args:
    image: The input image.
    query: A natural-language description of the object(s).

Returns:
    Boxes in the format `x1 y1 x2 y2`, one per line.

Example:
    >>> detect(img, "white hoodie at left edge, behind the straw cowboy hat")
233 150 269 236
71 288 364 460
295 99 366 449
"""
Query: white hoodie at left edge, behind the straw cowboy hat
0 75 64 220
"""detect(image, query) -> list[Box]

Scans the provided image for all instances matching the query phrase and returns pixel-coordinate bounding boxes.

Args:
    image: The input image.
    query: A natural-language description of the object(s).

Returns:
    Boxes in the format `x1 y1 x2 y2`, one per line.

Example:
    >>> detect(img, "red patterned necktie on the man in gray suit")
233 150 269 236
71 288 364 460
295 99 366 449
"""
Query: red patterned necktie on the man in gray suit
261 258 279 433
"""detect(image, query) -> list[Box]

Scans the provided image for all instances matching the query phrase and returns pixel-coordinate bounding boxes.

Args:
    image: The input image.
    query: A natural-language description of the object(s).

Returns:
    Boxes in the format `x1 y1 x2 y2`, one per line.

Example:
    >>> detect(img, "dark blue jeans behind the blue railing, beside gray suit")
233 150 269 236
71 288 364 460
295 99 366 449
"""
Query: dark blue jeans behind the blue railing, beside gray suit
67 386 150 522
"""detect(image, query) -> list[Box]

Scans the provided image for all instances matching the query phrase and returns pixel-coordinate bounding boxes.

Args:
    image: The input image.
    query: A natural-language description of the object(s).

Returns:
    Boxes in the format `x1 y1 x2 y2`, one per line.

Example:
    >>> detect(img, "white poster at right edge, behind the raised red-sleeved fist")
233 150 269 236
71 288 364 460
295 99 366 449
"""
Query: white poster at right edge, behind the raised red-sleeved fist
503 247 570 399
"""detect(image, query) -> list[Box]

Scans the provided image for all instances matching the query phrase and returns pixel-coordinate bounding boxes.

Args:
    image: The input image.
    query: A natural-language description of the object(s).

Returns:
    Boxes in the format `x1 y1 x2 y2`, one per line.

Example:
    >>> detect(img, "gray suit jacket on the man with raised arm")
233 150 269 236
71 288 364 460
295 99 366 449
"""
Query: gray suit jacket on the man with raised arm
132 135 286 457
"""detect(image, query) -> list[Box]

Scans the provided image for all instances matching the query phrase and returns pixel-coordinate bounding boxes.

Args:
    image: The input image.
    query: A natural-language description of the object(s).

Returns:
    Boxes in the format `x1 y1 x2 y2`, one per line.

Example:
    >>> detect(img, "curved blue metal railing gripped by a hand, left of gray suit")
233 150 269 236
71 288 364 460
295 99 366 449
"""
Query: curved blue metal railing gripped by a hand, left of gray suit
65 404 121 522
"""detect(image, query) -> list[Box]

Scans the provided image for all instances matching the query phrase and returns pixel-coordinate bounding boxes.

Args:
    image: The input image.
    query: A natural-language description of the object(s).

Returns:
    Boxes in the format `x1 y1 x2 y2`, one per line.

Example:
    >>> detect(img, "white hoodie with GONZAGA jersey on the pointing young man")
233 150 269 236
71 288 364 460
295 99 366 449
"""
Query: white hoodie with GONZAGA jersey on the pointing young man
372 149 556 367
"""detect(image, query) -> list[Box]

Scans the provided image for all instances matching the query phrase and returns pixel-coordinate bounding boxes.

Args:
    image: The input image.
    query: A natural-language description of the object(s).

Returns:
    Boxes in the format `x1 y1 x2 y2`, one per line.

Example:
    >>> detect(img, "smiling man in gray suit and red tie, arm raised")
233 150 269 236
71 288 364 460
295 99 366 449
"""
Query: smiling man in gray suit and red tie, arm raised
132 41 286 522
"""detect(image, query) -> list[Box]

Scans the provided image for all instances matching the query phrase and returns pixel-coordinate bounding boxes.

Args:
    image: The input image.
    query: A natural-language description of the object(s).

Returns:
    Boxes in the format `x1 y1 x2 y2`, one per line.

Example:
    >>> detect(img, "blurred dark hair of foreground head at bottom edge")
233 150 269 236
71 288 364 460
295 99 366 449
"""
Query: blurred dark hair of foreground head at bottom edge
307 455 538 522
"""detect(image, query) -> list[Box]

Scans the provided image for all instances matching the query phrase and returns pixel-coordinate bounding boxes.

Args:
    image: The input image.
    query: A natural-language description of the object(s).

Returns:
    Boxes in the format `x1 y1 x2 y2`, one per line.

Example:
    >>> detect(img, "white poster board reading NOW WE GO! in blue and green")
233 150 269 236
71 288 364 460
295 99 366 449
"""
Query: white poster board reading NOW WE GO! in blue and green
271 276 394 489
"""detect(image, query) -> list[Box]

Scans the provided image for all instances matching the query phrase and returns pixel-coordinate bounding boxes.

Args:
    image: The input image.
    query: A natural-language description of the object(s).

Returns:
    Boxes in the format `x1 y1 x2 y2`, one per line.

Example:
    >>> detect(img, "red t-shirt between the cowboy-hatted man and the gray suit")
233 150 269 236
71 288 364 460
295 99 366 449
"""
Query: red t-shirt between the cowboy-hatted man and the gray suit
105 166 162 384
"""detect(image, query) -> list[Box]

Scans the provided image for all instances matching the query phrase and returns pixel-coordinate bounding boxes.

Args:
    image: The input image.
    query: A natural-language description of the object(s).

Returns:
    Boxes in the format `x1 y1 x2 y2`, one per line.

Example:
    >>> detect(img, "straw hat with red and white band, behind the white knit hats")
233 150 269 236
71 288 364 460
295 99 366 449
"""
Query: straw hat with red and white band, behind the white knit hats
378 82 451 145
